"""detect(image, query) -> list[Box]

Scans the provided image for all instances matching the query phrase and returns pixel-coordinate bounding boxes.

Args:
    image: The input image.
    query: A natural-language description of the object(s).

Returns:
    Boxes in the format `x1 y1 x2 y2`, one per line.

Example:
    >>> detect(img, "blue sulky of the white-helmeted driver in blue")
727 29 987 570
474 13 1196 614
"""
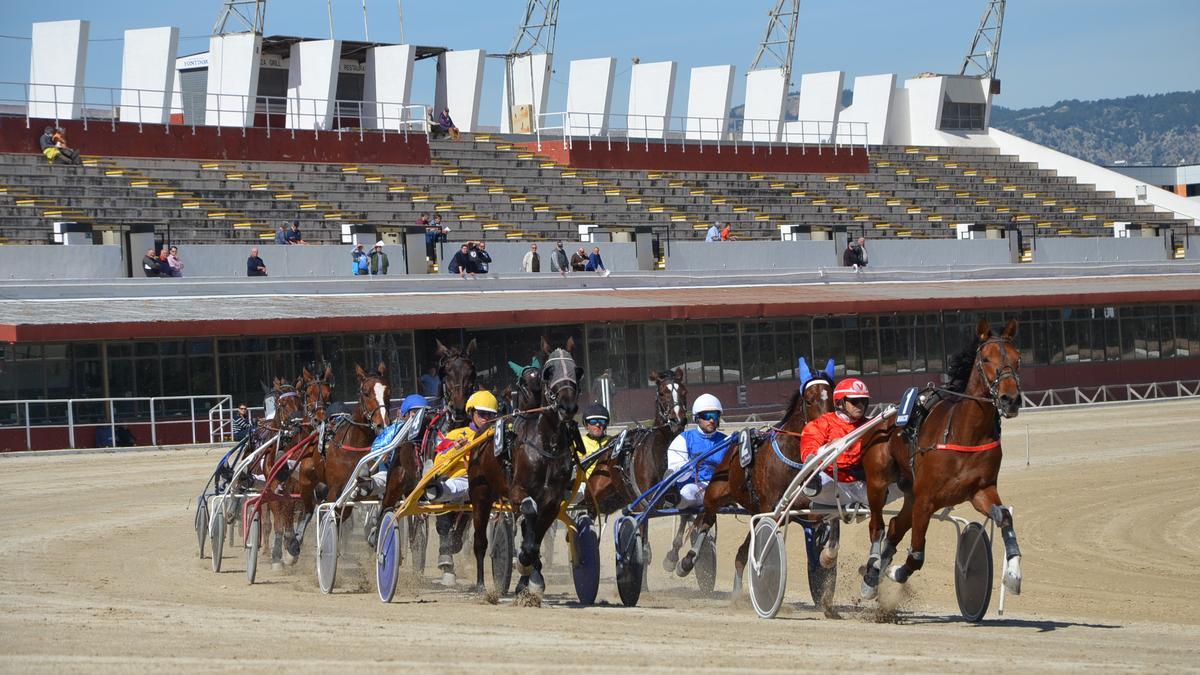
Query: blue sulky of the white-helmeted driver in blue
613 432 745 607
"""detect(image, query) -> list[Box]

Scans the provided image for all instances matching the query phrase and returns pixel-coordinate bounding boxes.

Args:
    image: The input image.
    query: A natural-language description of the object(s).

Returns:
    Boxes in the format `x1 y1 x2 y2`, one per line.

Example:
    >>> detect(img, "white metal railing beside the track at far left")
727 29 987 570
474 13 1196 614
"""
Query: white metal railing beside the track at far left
0 394 233 450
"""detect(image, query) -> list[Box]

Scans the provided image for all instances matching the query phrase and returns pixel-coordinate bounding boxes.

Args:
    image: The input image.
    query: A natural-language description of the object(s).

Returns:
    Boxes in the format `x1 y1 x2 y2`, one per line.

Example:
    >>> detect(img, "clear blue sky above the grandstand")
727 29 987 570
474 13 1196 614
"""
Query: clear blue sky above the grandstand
0 0 1200 124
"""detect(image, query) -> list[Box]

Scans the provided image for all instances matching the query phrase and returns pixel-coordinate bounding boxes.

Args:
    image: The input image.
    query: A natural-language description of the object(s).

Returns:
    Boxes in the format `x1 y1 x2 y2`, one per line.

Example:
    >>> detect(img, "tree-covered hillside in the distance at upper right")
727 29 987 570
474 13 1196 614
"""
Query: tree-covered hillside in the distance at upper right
991 91 1200 165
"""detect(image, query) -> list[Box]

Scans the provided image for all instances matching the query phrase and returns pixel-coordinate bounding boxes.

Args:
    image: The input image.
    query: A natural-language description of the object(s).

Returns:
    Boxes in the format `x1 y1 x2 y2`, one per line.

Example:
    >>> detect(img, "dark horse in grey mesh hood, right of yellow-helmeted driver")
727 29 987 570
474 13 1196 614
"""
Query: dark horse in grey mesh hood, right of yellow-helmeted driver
468 339 583 593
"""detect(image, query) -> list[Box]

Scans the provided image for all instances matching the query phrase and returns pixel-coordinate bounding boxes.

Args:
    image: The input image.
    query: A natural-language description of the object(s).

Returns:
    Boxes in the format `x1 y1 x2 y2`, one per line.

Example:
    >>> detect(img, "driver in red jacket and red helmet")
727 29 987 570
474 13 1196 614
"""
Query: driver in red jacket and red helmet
800 377 871 503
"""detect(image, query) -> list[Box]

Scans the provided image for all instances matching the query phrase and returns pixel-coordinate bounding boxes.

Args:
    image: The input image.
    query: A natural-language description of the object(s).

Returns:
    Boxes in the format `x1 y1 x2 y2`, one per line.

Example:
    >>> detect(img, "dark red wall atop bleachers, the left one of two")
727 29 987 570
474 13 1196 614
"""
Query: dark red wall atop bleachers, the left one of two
0 117 430 165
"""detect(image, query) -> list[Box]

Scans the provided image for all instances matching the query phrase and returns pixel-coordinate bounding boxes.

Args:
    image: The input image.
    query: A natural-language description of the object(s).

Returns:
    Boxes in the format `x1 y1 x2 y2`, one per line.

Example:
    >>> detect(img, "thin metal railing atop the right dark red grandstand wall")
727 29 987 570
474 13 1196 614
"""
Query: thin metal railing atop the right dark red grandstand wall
534 110 868 155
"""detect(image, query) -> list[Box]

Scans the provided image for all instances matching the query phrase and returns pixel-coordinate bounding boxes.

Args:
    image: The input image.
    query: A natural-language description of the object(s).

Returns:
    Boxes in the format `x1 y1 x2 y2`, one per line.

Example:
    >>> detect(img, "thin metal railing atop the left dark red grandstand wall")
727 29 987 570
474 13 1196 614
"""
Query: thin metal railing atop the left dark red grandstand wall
0 82 434 141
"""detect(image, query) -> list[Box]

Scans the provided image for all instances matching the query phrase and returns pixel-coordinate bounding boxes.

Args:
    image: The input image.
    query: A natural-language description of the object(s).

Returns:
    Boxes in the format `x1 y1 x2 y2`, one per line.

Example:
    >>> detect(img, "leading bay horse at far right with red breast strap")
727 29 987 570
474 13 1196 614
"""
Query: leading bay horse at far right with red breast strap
862 319 1021 598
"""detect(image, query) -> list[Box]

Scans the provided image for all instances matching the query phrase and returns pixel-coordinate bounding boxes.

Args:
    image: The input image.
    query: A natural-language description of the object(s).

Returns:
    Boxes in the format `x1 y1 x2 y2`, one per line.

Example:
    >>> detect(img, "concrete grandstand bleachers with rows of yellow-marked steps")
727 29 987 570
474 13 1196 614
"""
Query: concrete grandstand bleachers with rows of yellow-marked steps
0 135 1186 244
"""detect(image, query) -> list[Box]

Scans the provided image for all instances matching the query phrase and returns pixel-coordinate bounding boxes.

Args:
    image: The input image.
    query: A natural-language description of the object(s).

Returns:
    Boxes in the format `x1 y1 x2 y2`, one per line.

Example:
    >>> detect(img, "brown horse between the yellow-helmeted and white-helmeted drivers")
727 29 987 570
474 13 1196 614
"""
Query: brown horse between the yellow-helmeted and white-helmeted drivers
583 368 688 516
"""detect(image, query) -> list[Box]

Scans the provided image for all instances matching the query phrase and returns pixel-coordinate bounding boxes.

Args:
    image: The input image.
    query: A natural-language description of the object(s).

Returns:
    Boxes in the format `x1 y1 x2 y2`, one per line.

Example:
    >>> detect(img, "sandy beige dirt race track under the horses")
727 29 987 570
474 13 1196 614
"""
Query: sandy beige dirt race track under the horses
0 400 1200 673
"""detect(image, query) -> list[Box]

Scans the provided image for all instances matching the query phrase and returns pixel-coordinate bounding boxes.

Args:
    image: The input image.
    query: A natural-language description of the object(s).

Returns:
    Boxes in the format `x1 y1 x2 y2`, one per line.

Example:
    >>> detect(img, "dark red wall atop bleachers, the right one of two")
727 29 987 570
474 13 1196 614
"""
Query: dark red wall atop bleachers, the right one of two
517 139 871 173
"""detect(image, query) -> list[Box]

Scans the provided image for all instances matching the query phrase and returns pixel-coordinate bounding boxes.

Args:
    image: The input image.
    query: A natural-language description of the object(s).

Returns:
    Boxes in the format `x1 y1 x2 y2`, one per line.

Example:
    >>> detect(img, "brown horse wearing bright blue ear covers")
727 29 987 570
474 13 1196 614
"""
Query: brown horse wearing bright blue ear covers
676 359 838 596
